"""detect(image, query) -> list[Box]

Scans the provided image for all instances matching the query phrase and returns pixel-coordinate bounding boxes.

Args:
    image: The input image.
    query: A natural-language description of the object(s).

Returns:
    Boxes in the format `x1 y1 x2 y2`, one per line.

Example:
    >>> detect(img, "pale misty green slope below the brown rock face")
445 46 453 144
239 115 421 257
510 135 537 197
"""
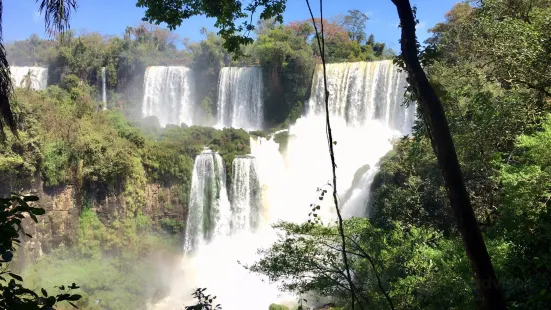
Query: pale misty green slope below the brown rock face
24 236 177 310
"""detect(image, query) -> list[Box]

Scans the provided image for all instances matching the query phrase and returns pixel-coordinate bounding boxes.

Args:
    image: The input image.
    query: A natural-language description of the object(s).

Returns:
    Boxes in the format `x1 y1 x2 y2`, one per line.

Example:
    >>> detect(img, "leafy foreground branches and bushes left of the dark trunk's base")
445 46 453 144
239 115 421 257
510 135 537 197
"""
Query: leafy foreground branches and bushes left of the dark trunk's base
249 218 473 309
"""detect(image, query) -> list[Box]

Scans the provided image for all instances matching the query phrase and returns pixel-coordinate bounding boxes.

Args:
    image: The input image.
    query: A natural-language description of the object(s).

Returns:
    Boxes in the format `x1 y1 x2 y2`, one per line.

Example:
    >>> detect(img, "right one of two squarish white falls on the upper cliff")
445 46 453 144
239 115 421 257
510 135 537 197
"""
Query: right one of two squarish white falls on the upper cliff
217 67 264 130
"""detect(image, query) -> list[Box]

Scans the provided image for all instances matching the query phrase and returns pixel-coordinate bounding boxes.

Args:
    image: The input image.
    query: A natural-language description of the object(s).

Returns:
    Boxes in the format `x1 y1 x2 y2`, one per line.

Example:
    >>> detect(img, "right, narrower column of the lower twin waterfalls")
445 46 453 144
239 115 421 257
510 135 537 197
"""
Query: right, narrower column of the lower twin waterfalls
231 156 261 233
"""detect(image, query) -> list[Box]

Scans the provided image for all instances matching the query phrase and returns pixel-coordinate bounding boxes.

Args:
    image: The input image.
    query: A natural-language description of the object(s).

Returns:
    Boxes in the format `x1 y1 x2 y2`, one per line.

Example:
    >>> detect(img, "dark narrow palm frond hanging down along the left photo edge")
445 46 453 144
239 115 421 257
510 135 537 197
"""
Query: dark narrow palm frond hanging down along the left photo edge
0 0 17 141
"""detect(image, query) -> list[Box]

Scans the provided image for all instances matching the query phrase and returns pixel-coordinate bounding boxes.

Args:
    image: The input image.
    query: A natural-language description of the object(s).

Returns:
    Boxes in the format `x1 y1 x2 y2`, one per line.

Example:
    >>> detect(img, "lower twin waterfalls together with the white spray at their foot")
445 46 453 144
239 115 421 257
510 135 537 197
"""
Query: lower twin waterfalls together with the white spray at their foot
152 149 284 310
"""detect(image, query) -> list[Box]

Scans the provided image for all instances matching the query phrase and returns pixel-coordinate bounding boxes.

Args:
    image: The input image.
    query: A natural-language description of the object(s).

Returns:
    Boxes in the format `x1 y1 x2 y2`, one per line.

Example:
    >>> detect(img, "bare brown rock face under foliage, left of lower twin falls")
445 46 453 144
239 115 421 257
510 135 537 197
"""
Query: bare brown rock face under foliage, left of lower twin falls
14 182 186 267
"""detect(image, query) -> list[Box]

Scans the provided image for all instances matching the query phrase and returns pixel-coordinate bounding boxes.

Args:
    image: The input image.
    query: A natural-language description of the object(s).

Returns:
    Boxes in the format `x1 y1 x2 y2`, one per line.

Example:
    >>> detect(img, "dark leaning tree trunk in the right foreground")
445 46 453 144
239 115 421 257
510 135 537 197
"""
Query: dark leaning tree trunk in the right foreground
392 0 506 309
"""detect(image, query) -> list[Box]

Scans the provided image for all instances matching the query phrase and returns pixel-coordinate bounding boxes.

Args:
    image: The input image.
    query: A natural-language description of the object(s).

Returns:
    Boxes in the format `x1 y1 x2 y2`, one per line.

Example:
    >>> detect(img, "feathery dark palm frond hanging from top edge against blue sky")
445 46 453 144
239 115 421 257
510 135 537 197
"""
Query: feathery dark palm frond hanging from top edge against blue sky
36 0 77 37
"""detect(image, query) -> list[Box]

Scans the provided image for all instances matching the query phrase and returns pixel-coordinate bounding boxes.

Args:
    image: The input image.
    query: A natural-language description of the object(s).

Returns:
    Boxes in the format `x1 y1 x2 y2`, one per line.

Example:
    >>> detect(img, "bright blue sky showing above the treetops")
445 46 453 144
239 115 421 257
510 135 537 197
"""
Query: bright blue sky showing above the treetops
3 0 459 50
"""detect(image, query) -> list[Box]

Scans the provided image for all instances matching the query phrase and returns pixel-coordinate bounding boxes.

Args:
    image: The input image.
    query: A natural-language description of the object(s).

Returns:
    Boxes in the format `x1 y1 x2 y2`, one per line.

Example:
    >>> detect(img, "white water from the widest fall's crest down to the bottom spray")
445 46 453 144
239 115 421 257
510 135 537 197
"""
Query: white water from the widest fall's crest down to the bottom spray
151 61 415 310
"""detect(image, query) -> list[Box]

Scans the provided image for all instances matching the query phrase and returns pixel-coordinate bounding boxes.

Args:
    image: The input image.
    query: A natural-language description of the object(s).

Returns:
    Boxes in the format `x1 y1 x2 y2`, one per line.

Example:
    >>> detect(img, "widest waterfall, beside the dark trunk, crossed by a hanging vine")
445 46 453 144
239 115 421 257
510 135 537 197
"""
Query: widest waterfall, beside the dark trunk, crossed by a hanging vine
286 60 415 217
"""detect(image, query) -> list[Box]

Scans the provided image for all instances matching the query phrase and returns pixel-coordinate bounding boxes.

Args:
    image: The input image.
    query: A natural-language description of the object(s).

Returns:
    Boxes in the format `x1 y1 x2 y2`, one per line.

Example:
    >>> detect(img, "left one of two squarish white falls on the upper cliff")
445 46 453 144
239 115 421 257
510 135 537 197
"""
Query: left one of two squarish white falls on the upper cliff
142 67 195 127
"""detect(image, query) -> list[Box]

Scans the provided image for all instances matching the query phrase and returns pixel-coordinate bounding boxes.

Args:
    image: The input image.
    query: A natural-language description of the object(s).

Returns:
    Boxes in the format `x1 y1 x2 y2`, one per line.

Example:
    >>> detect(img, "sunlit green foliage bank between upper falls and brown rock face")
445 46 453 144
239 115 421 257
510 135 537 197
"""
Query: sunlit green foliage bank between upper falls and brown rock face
4 81 250 202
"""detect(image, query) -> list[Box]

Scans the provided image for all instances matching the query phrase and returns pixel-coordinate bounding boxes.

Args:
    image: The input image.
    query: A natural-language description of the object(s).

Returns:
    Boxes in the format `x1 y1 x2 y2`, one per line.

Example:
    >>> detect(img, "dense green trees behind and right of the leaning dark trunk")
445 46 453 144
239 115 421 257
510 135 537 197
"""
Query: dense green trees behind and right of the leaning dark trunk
370 0 551 309
